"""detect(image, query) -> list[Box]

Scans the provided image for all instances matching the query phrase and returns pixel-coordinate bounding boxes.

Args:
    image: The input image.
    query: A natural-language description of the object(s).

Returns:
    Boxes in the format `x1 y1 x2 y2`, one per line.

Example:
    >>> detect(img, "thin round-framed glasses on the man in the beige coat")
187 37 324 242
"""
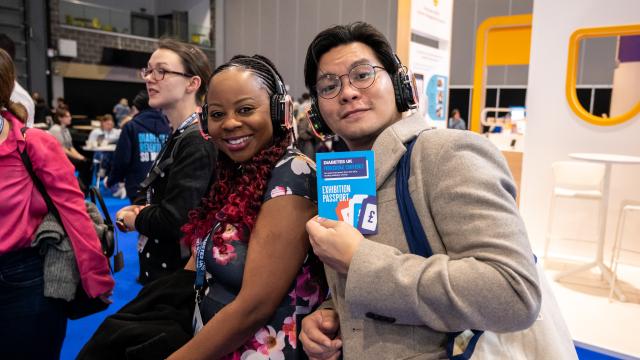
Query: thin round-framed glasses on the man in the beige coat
316 64 384 99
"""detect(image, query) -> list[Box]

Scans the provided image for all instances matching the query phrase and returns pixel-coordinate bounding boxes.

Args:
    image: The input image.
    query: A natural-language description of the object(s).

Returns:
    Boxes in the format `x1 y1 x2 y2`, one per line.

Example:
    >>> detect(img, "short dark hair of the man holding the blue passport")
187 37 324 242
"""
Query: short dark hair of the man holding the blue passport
304 21 398 97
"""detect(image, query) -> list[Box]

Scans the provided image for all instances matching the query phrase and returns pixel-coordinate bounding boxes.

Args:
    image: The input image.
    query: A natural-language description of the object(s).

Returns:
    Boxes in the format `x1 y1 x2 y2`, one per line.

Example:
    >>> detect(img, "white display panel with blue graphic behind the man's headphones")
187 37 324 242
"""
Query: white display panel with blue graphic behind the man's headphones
409 0 453 128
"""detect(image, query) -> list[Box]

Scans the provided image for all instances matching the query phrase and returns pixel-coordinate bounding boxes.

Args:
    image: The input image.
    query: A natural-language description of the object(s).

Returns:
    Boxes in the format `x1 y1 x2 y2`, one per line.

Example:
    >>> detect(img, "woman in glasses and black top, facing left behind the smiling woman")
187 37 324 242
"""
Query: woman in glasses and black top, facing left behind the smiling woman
116 39 217 284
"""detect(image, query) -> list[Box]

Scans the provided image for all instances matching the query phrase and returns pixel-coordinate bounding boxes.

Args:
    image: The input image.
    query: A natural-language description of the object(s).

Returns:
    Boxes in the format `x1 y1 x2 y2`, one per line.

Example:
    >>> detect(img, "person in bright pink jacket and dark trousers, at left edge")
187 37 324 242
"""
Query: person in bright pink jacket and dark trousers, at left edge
0 50 114 359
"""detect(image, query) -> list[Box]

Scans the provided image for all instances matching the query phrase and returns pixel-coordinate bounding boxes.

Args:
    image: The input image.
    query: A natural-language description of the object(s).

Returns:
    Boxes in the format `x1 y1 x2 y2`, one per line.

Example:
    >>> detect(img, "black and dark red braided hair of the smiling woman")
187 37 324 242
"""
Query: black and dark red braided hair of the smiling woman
181 55 291 252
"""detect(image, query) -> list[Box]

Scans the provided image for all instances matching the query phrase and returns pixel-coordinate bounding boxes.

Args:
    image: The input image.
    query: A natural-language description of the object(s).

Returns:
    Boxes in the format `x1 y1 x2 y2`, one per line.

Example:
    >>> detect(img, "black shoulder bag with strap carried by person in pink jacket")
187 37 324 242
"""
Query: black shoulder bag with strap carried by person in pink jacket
19 128 124 320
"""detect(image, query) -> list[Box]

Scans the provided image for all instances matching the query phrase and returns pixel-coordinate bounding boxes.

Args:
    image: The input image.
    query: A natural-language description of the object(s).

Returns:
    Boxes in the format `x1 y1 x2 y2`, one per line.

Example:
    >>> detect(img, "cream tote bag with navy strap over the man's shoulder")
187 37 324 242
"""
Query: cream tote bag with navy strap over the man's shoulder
396 134 578 360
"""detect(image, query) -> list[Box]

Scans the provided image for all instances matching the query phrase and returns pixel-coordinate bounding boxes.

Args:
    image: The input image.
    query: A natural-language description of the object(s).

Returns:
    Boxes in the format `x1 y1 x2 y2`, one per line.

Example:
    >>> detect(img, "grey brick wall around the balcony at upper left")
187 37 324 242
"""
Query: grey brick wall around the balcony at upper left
49 0 215 64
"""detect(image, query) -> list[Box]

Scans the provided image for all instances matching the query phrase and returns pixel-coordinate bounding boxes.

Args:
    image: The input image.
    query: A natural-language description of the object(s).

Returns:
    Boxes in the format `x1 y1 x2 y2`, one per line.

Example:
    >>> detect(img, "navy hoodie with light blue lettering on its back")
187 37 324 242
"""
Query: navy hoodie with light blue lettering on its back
108 109 171 198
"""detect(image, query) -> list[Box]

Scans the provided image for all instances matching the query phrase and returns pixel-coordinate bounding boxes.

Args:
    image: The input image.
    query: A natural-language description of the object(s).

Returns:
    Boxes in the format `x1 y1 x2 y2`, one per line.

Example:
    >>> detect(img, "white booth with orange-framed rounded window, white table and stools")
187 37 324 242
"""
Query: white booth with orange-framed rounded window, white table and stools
520 0 640 357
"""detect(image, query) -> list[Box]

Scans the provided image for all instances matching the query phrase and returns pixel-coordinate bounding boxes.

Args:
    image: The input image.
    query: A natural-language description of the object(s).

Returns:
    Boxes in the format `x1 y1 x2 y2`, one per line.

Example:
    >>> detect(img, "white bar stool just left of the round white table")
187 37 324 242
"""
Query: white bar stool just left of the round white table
544 161 605 259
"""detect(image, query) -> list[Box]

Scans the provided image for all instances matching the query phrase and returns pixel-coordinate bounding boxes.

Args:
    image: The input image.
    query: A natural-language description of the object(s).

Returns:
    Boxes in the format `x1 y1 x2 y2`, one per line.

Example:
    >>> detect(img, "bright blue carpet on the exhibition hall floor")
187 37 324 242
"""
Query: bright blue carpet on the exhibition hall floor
60 194 617 360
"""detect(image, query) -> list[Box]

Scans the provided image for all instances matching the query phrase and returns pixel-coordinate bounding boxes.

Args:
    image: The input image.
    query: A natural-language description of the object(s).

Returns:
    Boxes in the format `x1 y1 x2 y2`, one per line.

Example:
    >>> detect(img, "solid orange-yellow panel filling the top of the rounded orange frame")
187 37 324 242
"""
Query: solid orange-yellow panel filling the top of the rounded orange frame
486 26 531 65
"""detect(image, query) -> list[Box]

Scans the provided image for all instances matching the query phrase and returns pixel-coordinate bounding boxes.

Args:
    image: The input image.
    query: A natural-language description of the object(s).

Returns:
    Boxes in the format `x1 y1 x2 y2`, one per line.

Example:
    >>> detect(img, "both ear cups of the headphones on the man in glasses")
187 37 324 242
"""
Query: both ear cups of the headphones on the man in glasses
307 54 418 140
